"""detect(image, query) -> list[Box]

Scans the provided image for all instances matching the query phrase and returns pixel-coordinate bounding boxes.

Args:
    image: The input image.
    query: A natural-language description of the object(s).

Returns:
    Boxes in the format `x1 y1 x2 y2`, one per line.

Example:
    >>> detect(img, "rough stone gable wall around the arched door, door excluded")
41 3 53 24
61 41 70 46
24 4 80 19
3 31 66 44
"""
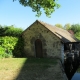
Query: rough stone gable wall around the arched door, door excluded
22 22 61 58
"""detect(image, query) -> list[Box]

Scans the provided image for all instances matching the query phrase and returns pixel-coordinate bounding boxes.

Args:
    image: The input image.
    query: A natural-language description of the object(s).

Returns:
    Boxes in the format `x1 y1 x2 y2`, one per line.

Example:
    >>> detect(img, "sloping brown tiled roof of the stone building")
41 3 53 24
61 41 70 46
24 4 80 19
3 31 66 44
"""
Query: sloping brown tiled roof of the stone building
36 20 78 43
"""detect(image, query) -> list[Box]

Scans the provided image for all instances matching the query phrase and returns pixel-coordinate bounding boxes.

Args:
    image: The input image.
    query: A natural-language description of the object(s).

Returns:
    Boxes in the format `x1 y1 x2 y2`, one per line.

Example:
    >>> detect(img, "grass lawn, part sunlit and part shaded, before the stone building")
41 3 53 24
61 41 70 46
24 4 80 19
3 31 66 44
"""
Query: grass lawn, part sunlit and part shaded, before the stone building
0 58 57 80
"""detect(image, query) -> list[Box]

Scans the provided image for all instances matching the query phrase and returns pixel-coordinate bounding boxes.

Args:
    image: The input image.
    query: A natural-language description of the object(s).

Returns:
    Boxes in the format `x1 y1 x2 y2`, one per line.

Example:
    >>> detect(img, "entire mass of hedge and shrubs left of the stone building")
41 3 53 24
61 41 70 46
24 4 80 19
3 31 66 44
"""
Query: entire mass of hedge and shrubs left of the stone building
0 25 23 57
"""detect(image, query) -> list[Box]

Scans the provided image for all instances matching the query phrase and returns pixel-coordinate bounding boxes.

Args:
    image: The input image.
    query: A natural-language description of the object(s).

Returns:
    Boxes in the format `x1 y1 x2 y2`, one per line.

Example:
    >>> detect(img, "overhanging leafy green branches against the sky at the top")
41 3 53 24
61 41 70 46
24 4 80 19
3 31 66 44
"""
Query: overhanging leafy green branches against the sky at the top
13 0 60 17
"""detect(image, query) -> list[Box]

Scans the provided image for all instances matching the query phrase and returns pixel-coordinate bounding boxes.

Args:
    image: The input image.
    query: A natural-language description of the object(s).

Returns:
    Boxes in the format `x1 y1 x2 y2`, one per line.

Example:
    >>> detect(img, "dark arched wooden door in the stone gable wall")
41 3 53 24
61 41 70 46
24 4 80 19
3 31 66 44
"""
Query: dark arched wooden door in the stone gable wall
35 39 43 58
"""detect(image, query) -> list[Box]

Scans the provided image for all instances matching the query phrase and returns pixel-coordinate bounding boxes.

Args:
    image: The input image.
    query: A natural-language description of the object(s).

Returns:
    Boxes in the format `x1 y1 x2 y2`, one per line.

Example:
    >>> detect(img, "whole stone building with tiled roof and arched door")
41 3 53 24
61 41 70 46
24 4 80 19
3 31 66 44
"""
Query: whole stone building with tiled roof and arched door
22 20 77 59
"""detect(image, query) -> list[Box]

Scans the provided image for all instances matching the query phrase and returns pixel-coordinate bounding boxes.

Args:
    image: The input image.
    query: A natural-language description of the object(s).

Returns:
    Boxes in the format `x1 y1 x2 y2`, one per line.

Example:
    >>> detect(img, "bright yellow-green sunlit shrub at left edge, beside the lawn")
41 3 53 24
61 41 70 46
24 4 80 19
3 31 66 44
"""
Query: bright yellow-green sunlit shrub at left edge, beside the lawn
0 36 18 58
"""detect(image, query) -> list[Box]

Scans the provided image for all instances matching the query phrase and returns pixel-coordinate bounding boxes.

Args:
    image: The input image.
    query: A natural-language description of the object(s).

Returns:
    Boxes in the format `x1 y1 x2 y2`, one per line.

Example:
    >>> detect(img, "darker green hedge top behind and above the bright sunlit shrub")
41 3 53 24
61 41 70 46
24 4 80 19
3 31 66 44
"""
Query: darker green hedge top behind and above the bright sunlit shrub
0 25 23 37
